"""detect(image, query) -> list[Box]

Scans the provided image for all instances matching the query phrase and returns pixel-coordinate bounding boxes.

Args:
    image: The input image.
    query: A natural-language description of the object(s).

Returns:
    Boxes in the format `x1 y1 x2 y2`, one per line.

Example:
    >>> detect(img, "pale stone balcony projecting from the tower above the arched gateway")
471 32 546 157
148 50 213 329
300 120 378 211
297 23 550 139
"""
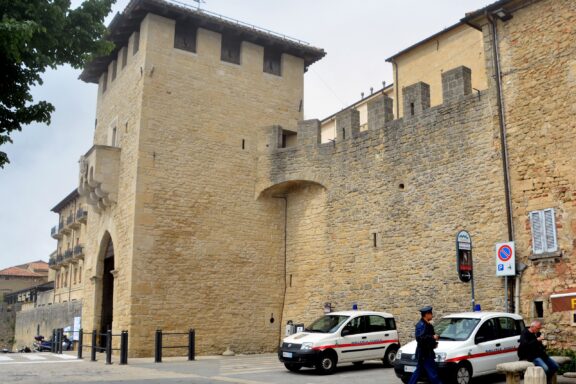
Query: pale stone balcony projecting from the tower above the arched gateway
78 145 120 213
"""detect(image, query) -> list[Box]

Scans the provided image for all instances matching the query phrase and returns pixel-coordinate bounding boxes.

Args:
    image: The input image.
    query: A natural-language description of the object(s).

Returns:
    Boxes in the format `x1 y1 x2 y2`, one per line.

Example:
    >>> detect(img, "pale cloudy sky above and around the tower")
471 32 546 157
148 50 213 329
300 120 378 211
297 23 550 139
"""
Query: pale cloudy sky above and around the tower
0 0 495 269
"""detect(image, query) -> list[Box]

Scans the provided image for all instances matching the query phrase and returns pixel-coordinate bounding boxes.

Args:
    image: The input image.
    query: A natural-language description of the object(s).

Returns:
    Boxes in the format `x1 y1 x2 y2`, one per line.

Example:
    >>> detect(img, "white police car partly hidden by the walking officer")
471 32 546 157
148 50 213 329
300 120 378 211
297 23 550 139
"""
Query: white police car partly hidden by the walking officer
394 312 525 384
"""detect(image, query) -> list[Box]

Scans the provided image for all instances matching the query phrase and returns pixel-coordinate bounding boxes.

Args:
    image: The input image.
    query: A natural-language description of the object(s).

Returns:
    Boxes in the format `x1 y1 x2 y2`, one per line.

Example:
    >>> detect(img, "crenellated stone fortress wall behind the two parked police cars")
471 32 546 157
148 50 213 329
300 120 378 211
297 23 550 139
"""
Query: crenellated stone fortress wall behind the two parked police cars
256 67 506 342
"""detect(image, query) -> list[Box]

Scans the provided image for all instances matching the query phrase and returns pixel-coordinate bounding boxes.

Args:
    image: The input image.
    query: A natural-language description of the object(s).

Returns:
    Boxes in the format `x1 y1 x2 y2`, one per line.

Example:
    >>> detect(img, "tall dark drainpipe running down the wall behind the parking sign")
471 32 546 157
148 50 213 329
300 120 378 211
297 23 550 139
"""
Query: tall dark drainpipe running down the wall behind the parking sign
486 13 520 312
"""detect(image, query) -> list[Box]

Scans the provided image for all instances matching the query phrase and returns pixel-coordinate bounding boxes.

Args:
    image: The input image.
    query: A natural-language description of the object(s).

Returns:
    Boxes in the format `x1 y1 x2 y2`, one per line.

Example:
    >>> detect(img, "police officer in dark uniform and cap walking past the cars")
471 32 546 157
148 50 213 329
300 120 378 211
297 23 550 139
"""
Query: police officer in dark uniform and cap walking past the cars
408 306 442 384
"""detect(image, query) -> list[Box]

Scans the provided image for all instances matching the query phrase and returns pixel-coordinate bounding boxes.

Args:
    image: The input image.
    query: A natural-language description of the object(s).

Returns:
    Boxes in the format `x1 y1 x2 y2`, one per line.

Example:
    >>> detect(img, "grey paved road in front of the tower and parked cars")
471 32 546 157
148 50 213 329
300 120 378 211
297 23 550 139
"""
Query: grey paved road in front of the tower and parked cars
0 353 568 384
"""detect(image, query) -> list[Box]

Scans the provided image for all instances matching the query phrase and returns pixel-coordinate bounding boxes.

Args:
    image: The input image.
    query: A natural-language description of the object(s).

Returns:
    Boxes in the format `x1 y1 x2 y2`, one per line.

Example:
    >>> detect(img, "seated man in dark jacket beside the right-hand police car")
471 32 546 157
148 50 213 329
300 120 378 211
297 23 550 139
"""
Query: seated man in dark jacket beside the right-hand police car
518 320 560 383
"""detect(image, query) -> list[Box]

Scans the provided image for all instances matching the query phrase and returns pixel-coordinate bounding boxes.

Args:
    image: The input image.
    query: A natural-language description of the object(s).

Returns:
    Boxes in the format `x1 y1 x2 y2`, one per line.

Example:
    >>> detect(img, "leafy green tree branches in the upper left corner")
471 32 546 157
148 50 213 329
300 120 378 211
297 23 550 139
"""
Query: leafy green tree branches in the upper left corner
0 0 114 168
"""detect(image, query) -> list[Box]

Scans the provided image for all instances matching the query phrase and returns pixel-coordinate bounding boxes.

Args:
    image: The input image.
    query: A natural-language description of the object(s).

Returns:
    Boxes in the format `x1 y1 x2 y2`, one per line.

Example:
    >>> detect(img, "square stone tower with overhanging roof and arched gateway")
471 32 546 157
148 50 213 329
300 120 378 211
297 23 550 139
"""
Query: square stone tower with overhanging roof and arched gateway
79 0 325 356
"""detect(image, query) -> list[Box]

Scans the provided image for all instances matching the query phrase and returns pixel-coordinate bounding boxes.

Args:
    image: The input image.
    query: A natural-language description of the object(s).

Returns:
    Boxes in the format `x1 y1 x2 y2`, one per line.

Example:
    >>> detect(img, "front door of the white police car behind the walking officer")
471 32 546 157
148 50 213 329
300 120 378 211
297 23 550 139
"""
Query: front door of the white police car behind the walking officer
470 318 499 376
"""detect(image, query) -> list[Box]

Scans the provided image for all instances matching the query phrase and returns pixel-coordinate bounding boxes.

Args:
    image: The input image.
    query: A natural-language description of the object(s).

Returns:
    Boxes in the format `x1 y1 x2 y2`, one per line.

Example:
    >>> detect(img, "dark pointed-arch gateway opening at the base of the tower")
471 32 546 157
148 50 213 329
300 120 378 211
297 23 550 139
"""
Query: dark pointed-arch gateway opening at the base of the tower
96 231 114 347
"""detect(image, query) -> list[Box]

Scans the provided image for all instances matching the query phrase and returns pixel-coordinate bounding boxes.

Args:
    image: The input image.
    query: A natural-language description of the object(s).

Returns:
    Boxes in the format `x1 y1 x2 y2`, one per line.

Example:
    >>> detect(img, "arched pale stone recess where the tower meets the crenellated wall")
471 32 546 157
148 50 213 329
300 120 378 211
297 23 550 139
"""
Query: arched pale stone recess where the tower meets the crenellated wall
259 180 331 335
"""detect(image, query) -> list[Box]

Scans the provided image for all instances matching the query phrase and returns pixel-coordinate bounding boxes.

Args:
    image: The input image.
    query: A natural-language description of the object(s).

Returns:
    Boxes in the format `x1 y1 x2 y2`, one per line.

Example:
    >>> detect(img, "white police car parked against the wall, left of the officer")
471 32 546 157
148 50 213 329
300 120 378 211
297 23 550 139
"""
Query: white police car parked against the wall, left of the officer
278 311 399 374
